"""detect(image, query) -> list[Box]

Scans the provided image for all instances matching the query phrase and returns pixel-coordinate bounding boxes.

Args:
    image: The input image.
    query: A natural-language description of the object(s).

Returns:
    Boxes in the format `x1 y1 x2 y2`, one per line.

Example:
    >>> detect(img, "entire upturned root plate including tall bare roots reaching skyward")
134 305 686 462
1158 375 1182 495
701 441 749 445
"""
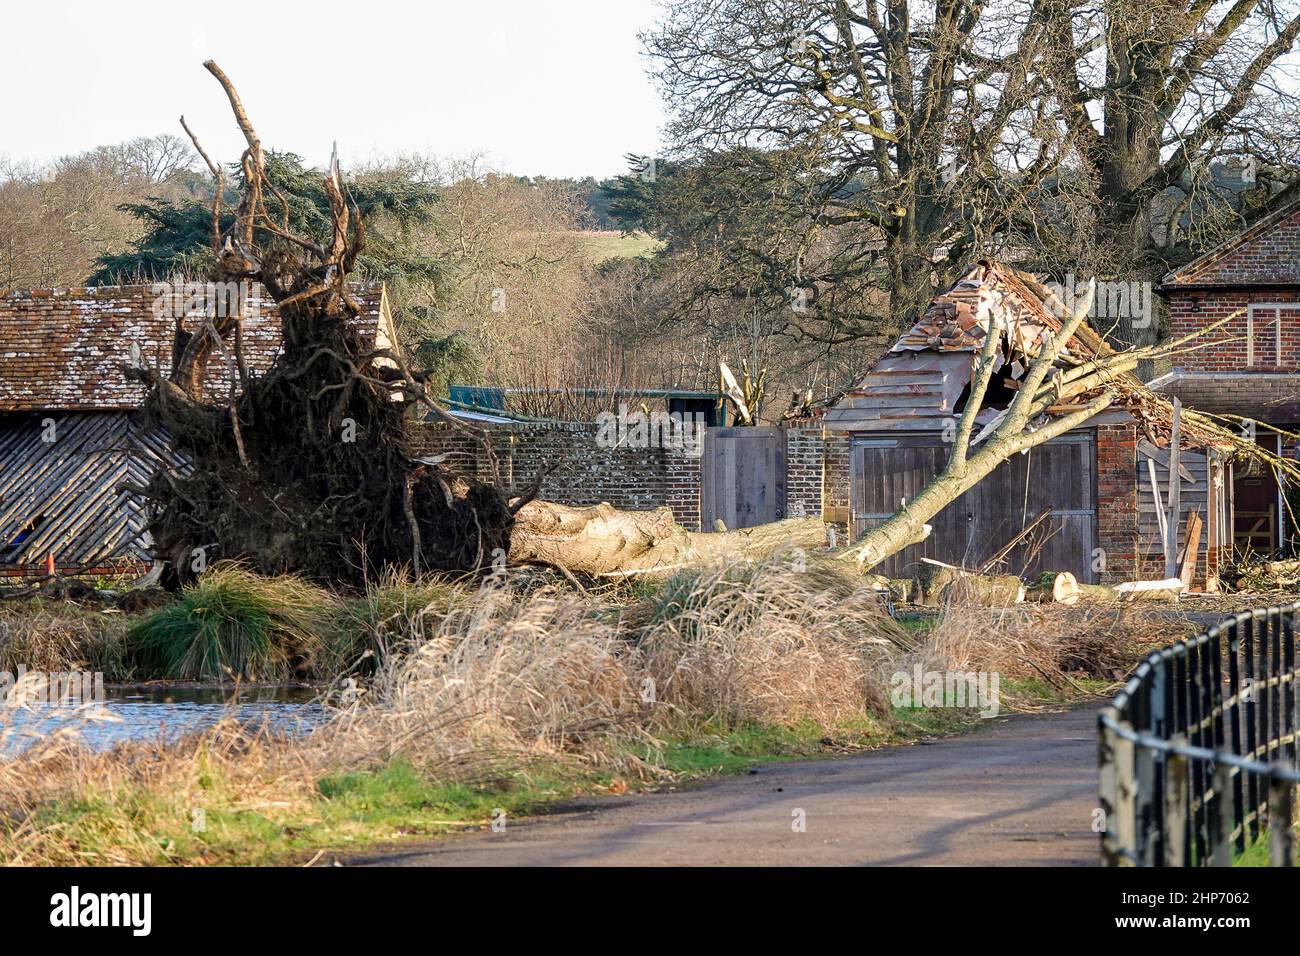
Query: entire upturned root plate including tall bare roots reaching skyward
124 61 527 583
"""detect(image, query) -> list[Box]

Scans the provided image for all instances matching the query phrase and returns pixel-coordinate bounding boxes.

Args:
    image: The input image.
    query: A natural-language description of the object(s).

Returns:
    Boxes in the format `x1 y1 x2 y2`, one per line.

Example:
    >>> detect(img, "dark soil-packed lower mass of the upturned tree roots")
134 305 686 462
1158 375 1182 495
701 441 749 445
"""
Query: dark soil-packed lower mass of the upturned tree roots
134 300 514 581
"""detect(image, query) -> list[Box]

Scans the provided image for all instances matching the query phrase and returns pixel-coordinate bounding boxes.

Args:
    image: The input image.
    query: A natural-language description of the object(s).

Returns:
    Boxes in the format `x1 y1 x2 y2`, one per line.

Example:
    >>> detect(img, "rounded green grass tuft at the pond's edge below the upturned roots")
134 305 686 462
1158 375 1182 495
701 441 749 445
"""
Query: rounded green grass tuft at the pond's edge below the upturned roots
127 564 337 682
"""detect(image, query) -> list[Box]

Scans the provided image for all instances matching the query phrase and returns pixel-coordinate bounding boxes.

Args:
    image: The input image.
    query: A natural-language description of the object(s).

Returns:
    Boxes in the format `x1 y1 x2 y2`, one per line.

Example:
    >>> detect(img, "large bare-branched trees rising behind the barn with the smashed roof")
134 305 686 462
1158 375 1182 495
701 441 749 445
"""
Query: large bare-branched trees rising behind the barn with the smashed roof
645 0 1300 351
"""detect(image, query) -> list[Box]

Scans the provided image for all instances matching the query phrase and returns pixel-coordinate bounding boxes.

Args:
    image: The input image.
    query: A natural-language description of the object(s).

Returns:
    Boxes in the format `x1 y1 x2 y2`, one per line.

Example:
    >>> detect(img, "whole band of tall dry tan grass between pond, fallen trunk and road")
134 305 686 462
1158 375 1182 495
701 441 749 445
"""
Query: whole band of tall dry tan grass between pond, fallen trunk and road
0 559 907 864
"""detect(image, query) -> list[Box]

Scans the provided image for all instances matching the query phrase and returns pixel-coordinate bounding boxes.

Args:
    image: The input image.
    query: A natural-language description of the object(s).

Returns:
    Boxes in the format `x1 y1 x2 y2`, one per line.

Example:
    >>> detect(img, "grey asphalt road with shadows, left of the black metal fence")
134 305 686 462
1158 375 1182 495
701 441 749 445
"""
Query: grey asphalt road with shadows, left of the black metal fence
342 706 1097 866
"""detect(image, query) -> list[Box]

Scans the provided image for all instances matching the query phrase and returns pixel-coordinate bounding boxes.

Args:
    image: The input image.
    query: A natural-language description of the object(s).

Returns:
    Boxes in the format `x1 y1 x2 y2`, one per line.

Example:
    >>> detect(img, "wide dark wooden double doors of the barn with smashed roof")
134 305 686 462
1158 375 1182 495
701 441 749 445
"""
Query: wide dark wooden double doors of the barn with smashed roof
850 432 1097 583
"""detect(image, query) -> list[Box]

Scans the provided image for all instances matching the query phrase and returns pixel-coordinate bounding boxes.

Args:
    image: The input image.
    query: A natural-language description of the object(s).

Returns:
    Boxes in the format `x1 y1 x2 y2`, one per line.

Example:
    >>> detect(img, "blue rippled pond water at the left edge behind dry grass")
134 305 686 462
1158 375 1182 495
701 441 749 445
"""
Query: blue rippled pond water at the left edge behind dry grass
0 687 325 754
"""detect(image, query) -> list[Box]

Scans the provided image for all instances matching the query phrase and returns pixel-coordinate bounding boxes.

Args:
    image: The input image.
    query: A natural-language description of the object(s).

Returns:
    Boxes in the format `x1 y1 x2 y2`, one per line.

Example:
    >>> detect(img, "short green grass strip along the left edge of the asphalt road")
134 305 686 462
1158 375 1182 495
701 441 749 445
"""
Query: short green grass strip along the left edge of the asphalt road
3 710 979 865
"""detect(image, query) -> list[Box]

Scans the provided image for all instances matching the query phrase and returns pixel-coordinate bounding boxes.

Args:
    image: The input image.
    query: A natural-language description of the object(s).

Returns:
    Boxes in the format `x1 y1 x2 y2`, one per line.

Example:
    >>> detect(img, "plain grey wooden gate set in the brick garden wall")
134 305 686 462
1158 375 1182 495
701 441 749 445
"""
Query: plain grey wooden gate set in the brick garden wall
699 425 785 531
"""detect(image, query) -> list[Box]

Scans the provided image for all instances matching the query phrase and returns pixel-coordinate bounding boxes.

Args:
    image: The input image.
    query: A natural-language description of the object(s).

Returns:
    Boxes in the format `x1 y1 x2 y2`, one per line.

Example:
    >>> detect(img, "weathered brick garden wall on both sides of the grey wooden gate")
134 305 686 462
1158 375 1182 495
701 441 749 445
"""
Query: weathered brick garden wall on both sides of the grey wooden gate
415 423 826 531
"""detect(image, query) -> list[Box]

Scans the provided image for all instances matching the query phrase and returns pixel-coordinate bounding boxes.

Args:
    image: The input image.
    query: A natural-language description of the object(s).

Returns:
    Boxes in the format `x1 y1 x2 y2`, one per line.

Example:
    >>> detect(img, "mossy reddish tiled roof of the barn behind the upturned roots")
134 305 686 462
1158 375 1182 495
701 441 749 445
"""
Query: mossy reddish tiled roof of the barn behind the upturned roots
0 282 391 411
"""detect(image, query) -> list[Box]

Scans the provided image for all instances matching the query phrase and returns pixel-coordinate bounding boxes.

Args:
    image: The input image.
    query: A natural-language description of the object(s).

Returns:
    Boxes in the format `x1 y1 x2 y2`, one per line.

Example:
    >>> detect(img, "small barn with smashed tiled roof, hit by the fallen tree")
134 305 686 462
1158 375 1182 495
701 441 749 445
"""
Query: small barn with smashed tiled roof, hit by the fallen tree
823 261 1232 588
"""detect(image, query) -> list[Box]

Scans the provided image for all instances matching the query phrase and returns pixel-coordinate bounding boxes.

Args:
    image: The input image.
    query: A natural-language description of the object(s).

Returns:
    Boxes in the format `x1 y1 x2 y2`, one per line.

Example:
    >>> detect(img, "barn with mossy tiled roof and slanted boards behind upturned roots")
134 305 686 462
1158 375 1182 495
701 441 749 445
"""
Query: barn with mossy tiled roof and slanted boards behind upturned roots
0 284 397 576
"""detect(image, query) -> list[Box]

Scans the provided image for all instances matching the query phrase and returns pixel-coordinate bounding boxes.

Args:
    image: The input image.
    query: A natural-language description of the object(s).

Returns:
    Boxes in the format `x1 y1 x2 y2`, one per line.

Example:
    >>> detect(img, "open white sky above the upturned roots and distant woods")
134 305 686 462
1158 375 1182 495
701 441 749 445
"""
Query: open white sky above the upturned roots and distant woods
0 0 663 177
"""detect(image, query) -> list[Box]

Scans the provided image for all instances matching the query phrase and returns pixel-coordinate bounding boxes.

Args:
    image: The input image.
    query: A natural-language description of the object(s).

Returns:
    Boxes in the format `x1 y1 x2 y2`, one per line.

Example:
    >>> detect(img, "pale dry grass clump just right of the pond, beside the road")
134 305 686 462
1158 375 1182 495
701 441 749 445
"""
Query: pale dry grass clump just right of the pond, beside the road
328 587 650 780
